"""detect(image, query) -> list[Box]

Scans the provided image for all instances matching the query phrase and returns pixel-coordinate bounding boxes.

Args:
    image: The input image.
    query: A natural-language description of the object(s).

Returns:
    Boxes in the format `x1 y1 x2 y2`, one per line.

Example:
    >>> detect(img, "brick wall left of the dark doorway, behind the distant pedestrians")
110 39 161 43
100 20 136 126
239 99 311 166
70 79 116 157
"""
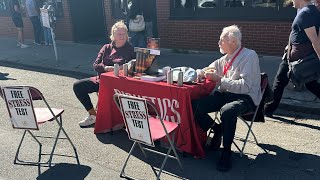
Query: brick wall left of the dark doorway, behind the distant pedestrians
0 1 73 41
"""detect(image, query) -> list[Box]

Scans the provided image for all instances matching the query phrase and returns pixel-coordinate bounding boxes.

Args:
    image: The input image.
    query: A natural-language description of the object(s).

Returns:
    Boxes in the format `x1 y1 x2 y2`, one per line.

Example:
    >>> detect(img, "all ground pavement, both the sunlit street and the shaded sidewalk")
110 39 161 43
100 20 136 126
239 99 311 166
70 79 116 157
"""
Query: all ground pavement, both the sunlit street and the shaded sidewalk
0 37 320 180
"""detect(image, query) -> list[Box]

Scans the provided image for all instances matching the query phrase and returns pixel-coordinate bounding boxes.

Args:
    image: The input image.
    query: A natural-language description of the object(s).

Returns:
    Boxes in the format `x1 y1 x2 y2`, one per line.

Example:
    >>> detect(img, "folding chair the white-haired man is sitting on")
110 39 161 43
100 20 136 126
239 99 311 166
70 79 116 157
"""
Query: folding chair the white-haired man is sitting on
208 73 268 156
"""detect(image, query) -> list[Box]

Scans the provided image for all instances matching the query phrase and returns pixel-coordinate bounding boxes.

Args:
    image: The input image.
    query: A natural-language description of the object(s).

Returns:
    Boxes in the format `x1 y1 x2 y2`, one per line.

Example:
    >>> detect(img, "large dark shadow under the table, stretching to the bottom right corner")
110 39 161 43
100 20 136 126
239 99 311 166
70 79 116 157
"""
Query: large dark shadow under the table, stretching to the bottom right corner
97 130 320 180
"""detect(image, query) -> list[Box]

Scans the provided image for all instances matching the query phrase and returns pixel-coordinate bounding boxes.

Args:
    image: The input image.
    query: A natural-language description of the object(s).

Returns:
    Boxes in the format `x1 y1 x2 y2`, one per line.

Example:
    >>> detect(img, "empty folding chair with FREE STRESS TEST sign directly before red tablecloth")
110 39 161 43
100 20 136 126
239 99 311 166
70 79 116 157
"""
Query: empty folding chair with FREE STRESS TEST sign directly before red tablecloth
113 94 182 179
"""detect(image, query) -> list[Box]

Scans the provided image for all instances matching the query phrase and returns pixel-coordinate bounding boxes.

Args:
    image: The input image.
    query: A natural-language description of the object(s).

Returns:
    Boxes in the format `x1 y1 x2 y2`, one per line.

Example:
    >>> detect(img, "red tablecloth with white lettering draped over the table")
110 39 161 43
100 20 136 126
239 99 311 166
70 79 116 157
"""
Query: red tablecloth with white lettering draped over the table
94 72 215 157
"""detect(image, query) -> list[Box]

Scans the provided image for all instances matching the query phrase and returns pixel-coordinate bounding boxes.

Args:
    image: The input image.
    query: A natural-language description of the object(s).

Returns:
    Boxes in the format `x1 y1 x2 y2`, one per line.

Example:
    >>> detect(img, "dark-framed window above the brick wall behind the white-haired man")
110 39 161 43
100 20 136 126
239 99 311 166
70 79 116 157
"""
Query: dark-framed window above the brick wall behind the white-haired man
170 0 297 20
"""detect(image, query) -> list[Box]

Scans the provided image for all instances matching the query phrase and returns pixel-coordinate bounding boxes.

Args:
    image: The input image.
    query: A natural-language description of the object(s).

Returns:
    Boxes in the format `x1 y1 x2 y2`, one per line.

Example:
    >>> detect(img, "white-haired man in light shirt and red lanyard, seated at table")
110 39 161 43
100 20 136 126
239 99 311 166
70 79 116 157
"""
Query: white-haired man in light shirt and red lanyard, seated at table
192 25 262 171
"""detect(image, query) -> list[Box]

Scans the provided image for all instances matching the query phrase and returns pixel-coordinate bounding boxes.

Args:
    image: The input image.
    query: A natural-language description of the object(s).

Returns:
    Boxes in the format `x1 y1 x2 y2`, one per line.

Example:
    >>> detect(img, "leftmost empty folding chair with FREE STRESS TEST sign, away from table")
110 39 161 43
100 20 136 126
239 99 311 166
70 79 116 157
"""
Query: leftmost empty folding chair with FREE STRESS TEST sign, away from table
0 86 80 167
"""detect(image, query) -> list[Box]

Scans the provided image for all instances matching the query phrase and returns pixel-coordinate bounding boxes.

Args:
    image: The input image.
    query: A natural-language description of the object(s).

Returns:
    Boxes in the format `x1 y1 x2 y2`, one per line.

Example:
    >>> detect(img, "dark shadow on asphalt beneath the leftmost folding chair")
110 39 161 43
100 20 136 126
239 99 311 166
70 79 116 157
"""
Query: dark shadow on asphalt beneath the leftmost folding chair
37 163 91 180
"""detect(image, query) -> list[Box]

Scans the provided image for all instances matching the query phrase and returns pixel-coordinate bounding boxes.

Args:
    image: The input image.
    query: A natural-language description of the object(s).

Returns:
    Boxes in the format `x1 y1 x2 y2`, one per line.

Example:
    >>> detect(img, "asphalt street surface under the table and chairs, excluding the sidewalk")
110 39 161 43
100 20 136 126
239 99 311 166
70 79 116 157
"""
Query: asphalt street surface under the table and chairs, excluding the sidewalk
0 66 320 180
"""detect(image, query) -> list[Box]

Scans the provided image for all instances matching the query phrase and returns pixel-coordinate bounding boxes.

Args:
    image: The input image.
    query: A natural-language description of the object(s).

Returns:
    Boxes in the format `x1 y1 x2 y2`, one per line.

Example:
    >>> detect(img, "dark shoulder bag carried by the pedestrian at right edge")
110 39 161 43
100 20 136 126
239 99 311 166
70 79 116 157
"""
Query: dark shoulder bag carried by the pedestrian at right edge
288 53 320 84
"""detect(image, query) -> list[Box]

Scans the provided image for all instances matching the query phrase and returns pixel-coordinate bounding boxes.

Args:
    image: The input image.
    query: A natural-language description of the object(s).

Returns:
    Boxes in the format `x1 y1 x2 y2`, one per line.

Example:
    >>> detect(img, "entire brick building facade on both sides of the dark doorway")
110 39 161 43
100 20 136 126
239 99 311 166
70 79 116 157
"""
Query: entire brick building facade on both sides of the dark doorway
0 0 292 55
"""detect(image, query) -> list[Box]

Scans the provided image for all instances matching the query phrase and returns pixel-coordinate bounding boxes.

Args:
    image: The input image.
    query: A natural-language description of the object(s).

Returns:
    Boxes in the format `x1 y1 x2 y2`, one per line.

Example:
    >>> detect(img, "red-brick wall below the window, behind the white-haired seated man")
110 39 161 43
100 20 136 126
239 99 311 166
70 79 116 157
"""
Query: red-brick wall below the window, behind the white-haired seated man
156 0 291 55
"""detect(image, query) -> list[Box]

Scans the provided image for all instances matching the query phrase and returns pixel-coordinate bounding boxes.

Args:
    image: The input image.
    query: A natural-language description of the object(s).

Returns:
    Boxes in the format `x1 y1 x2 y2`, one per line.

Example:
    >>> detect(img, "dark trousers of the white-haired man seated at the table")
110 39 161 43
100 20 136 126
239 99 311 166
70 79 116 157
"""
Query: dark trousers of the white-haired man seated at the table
192 92 255 150
